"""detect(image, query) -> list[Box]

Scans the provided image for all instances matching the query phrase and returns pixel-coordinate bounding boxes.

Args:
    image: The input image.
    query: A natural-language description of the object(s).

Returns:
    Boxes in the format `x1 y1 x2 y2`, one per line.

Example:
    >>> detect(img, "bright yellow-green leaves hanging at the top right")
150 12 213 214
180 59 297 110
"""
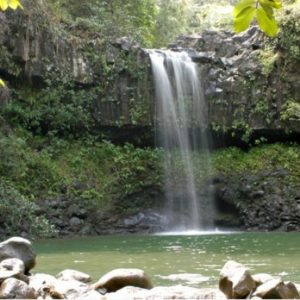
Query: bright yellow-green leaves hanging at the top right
233 0 282 37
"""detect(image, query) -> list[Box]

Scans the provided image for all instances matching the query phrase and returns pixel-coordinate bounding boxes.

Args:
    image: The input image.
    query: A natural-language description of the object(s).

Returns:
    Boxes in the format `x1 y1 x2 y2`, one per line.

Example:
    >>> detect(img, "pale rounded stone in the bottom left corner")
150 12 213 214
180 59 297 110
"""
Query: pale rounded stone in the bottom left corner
0 278 37 299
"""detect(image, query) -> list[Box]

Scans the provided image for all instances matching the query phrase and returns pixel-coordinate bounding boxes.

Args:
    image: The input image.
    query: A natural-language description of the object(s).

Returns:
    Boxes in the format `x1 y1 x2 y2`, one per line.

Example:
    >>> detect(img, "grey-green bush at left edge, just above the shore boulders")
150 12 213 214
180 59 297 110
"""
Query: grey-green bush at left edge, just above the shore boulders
0 181 56 238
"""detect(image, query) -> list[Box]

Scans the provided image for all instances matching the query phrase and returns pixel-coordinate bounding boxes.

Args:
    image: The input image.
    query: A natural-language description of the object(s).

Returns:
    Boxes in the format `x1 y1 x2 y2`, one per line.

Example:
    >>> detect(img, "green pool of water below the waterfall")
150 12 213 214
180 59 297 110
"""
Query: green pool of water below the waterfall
34 233 300 287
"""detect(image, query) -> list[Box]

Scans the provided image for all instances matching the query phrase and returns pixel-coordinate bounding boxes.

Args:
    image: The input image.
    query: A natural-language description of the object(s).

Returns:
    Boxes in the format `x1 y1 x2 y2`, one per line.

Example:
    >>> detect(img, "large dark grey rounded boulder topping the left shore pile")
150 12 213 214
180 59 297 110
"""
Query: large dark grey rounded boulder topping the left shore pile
0 237 36 274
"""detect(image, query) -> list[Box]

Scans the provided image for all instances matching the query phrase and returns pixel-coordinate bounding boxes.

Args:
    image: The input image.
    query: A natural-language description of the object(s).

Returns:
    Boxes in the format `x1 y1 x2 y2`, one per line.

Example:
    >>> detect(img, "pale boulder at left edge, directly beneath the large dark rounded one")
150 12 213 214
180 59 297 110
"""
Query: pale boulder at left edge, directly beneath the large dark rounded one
0 258 28 283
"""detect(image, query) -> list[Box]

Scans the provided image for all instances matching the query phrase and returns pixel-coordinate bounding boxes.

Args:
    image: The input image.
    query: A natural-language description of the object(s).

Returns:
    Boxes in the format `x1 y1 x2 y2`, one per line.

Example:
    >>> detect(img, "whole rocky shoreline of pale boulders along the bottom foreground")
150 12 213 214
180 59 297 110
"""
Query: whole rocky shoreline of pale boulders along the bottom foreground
0 237 300 300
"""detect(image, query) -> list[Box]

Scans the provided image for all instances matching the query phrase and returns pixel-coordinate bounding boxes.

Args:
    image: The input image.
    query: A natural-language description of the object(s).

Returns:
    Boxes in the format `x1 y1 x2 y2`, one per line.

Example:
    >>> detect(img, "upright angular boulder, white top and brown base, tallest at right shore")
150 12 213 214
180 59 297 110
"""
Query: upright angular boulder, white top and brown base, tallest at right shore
219 261 256 299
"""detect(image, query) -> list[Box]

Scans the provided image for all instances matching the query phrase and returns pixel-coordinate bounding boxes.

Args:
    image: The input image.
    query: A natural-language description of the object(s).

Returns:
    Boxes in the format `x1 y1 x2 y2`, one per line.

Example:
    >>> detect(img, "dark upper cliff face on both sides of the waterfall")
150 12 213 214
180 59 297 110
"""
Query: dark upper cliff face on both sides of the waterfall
0 5 300 145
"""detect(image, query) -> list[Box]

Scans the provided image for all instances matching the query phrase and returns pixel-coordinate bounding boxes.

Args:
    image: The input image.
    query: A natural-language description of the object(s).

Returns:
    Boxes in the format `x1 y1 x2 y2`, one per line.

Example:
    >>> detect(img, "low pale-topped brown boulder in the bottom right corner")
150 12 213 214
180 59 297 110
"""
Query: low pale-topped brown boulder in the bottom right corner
253 279 300 299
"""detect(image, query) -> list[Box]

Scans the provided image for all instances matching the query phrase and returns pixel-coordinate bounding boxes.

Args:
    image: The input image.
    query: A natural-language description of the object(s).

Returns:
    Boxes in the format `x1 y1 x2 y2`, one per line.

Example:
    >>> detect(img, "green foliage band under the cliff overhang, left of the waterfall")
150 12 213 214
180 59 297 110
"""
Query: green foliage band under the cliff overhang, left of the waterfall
0 127 161 208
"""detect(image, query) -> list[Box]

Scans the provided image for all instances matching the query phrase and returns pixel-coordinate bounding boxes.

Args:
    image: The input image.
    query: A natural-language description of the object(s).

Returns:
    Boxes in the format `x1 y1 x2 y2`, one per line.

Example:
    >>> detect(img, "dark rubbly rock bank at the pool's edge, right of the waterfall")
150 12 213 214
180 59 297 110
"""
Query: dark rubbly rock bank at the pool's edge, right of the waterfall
215 168 300 231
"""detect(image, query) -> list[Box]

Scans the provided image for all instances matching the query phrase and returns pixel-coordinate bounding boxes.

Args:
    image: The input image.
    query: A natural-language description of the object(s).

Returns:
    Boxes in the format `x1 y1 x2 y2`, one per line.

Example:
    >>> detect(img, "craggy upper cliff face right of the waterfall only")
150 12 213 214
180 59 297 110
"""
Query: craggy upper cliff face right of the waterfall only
173 27 300 143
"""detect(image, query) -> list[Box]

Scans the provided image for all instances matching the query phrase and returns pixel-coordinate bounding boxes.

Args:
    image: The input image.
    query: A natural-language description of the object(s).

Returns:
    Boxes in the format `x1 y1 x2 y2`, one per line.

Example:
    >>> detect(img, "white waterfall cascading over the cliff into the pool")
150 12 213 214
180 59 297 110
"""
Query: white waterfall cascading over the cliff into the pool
149 50 212 230
